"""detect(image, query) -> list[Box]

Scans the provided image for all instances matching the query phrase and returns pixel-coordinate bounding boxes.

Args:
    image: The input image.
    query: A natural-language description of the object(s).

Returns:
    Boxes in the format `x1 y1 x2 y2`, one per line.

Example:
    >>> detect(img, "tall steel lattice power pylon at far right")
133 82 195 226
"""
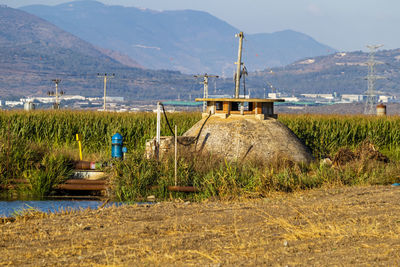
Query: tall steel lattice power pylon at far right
364 45 385 115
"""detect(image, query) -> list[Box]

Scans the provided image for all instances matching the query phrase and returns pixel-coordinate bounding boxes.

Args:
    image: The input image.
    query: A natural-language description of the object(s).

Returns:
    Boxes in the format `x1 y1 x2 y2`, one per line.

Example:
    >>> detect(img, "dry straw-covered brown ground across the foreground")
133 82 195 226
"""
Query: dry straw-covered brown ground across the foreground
0 186 400 266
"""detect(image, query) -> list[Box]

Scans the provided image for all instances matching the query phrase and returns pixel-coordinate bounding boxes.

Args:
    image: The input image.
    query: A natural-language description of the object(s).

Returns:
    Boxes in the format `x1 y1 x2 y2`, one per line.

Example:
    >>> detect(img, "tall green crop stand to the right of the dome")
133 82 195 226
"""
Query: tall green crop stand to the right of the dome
279 115 400 158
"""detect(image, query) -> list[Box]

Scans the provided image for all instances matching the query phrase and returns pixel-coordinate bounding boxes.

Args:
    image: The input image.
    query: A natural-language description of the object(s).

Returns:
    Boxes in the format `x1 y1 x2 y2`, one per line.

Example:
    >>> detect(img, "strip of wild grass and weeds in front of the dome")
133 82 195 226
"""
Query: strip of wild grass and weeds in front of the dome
111 151 400 201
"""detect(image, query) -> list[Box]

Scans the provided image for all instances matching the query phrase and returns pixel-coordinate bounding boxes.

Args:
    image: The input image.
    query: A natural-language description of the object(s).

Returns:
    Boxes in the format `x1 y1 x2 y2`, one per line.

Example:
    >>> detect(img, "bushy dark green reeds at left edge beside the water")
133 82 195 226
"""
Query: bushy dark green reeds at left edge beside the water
0 134 73 198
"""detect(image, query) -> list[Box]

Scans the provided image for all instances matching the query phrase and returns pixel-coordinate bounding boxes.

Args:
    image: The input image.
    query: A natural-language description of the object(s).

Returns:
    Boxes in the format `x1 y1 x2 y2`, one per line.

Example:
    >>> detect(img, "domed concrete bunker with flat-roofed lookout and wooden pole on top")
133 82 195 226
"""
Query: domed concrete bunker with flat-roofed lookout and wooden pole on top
146 32 313 163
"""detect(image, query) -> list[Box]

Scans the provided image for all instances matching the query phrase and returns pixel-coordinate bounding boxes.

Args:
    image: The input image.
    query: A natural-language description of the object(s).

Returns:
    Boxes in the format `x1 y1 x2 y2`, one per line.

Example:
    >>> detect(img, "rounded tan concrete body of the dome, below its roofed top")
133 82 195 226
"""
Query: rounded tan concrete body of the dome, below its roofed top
184 115 313 163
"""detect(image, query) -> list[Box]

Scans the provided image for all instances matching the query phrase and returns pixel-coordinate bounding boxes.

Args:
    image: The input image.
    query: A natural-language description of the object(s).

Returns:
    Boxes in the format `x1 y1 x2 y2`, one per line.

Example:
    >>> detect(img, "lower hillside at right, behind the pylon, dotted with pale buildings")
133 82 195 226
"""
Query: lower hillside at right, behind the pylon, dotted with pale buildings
247 49 400 96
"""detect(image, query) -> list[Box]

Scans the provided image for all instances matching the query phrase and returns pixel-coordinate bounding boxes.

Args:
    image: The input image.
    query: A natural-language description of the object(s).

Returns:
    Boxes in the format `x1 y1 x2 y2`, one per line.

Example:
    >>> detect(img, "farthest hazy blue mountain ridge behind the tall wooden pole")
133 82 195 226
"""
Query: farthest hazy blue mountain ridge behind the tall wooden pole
22 1 334 77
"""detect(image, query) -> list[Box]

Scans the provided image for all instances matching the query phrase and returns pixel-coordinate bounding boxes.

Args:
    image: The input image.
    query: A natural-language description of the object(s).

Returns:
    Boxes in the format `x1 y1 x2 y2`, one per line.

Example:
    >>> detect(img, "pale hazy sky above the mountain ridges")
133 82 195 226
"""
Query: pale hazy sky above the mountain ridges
0 0 400 51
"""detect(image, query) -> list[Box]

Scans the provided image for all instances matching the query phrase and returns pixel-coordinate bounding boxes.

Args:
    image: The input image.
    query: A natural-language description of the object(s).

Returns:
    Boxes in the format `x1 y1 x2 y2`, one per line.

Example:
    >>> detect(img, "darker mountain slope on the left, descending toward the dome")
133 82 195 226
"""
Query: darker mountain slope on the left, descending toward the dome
0 6 193 99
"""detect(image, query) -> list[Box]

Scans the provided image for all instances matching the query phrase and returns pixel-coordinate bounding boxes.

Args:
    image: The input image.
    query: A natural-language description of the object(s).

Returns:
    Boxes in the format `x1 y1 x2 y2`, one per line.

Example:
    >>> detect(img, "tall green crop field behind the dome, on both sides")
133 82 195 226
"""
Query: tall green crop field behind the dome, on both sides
0 111 400 158
